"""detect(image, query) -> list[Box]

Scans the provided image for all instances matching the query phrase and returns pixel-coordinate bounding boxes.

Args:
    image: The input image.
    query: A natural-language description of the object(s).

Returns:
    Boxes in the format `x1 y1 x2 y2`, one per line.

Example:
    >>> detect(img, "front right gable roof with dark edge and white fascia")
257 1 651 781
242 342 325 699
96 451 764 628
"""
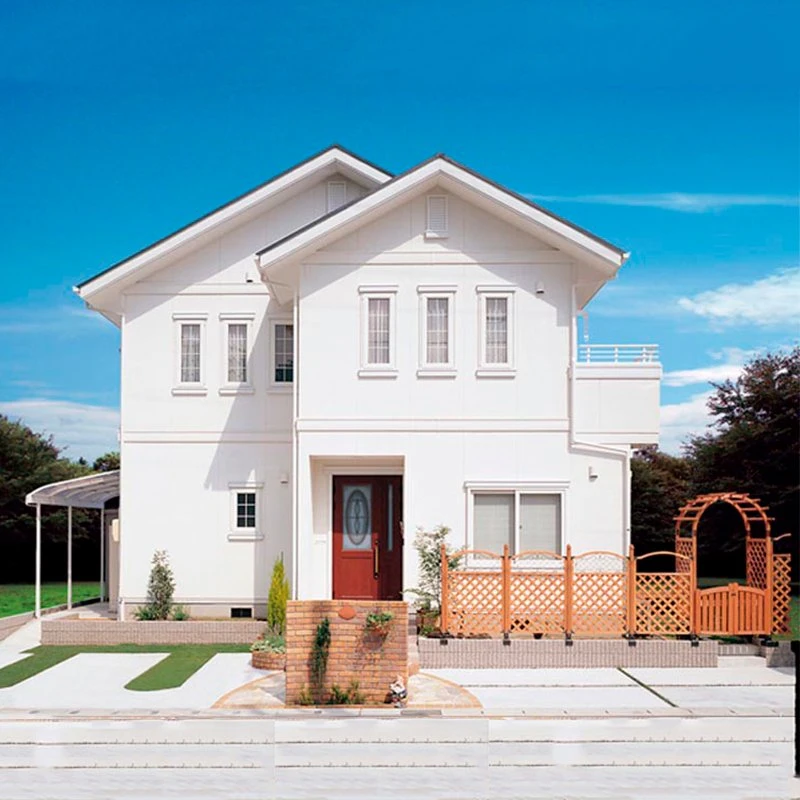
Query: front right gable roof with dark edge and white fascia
256 154 628 273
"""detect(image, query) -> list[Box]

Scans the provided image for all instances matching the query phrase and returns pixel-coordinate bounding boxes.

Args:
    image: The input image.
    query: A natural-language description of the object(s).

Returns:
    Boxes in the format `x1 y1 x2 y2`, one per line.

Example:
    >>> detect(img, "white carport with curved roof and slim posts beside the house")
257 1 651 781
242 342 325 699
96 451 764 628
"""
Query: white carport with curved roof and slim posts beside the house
25 470 119 618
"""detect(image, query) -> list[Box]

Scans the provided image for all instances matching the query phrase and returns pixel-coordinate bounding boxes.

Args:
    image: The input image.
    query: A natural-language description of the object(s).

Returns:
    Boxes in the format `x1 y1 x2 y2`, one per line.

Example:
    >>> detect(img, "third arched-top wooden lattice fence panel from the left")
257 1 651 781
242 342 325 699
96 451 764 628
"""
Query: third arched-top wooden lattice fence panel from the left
572 553 628 636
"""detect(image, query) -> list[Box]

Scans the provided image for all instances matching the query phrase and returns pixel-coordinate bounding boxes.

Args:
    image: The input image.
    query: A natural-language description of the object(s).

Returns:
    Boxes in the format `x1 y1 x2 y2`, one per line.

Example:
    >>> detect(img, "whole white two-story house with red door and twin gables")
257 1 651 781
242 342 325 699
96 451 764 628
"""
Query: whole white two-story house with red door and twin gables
77 147 661 617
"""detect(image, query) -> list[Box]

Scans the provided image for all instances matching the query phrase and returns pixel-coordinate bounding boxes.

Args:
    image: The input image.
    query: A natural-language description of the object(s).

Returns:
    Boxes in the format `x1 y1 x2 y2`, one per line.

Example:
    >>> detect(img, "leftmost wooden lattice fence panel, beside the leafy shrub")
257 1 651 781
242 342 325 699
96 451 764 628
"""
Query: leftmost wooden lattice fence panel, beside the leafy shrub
447 570 503 636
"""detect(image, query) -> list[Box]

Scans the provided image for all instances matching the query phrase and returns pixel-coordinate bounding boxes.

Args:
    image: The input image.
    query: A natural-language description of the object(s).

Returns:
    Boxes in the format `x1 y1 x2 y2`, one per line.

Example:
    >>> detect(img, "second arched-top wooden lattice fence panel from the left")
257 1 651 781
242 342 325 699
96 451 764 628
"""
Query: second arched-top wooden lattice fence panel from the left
508 551 566 633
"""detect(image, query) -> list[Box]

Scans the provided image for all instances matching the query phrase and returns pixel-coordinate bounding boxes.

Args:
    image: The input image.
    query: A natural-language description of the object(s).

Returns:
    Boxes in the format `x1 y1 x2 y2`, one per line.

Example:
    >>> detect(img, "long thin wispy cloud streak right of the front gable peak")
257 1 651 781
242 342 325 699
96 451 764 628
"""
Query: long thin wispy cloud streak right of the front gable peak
526 192 800 214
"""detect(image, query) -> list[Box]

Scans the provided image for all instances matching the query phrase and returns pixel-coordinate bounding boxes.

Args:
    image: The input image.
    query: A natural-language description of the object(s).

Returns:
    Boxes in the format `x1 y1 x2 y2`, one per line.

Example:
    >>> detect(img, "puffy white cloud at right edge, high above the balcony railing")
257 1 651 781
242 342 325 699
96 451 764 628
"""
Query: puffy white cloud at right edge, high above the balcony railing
678 267 800 327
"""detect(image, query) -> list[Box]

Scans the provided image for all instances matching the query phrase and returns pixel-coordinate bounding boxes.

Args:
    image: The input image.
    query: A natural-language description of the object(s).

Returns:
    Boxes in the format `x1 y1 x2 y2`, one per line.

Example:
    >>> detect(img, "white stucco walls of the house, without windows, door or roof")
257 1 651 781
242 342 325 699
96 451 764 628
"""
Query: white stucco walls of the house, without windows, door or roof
114 181 658 613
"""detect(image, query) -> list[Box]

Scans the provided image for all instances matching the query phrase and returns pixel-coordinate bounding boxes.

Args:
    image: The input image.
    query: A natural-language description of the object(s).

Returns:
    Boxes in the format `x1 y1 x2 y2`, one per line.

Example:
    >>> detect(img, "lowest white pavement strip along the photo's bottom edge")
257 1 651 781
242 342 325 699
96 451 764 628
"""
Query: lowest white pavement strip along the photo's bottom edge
3 765 798 800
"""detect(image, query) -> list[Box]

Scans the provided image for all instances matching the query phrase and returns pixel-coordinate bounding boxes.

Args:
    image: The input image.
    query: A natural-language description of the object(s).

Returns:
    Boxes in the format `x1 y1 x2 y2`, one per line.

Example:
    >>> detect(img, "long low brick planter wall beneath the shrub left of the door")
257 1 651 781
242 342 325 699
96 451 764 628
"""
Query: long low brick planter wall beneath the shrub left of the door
42 619 266 645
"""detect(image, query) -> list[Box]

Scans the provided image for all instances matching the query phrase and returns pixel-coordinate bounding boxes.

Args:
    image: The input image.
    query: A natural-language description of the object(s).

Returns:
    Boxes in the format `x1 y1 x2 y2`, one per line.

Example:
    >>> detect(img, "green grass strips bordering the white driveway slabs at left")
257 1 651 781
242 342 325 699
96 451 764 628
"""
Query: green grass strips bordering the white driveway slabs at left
0 644 250 692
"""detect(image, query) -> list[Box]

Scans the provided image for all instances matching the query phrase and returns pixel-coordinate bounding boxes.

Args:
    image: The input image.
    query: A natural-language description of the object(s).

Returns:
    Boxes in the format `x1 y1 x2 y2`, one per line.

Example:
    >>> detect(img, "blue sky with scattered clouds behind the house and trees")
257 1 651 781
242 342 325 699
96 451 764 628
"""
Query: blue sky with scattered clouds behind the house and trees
0 0 800 458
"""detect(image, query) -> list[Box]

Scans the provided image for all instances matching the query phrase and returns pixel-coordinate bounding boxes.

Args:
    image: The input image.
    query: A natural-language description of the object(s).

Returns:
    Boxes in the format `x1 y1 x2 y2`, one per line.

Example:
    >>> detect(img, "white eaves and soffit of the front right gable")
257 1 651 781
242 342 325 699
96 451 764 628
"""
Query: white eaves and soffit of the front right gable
256 156 628 284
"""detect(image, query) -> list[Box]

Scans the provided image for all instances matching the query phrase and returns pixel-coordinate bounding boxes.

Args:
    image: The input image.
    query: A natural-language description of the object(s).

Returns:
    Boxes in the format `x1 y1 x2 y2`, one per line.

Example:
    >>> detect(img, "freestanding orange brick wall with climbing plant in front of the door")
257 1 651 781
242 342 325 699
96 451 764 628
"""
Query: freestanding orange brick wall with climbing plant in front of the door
286 600 408 704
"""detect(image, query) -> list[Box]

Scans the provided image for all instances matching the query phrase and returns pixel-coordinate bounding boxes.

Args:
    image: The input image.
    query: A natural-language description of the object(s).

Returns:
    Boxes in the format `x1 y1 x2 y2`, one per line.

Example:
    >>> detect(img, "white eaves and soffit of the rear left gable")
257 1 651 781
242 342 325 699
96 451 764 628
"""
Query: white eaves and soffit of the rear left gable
75 146 392 322
